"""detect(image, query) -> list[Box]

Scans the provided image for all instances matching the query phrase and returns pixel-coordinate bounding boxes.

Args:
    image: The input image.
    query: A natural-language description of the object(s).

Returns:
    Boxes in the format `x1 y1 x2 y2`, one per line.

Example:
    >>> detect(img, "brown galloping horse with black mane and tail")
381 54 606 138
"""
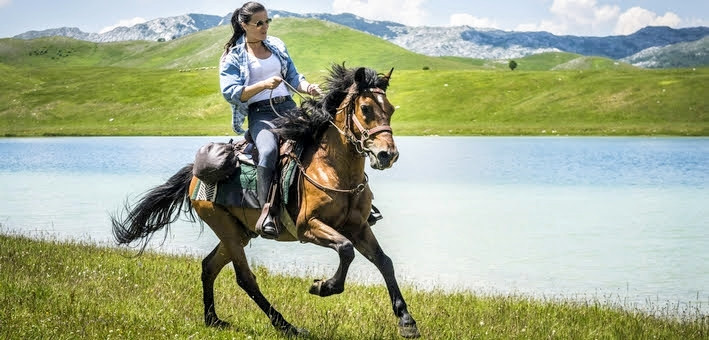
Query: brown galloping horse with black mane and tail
112 65 419 337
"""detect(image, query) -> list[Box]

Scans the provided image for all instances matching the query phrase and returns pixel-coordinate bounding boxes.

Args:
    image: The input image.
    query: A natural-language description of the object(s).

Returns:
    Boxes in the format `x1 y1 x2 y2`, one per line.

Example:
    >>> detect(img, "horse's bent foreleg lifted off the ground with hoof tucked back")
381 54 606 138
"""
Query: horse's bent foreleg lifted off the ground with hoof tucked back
302 219 354 296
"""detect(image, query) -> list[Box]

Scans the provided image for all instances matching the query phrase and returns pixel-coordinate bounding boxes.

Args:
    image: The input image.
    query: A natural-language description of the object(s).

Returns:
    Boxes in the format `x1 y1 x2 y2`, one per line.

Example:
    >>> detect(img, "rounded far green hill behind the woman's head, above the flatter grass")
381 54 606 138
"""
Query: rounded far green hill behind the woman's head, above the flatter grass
0 19 473 73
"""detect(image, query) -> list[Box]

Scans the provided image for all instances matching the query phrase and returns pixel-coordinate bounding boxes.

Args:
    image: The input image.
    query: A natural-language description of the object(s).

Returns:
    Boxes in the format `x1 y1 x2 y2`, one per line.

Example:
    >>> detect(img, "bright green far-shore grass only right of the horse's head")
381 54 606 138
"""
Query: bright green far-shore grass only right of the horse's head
391 69 709 135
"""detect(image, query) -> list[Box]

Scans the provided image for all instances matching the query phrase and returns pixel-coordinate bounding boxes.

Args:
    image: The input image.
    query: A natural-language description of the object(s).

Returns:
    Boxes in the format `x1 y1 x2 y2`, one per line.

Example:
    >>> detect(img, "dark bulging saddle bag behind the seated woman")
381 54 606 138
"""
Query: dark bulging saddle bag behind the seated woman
192 140 239 184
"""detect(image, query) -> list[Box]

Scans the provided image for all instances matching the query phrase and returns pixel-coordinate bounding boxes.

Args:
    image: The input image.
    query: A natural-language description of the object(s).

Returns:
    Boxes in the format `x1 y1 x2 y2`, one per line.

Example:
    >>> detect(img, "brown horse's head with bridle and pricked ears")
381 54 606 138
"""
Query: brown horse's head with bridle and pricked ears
338 68 399 170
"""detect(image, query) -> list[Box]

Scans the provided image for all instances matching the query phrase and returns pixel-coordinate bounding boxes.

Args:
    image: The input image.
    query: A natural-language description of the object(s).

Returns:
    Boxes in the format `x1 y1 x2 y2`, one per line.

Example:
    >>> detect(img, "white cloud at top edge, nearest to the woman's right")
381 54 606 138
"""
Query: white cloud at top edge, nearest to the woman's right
332 0 426 26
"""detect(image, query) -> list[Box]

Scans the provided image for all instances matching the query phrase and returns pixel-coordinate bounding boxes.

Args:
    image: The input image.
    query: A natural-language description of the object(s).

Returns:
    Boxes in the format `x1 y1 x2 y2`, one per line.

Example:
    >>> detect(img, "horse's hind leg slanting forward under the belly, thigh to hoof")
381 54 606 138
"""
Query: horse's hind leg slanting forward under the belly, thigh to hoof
193 201 302 335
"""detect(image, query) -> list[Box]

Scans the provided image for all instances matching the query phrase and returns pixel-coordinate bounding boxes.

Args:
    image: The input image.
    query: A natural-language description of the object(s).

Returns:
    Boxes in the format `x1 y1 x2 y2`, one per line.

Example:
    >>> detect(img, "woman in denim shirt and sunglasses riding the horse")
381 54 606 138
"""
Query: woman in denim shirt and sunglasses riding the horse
219 2 321 238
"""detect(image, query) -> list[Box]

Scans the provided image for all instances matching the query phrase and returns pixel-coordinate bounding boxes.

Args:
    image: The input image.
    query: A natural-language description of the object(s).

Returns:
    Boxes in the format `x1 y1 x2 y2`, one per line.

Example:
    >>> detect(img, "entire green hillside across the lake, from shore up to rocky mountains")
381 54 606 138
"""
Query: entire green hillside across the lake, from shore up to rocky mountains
0 19 709 136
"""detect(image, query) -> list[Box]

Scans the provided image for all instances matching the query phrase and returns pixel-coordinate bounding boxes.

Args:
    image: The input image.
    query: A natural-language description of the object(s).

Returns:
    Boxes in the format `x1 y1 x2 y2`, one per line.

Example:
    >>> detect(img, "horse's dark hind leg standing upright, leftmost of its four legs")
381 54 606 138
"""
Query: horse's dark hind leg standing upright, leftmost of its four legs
202 243 231 328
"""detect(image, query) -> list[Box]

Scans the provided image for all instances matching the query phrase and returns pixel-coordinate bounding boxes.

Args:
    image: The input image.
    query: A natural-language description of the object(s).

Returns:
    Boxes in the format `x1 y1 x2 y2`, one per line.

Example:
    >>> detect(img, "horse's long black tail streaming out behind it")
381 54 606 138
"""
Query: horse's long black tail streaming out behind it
111 164 195 253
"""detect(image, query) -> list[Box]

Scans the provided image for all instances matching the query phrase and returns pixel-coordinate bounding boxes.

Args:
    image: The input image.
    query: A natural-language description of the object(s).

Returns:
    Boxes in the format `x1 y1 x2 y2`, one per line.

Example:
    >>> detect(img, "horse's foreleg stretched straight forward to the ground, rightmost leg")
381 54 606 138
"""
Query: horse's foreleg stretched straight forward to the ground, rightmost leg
353 226 420 338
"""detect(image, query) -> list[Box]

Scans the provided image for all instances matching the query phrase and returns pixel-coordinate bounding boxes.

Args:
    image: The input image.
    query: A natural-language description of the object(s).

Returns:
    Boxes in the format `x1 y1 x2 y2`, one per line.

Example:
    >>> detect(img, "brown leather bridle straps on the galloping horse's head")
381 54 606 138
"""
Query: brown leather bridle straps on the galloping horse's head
331 85 393 157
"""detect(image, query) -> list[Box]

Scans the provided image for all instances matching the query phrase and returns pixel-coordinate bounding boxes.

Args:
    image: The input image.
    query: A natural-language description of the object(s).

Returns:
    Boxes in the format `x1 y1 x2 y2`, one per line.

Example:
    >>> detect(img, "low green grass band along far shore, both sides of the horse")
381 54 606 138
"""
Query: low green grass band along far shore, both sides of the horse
0 65 709 136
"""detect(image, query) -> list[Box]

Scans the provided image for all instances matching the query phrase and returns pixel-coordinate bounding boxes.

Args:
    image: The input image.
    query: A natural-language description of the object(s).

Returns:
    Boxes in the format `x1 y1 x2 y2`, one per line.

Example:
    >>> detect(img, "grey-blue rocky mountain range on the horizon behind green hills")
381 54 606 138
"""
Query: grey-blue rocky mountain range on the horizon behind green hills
15 10 709 67
